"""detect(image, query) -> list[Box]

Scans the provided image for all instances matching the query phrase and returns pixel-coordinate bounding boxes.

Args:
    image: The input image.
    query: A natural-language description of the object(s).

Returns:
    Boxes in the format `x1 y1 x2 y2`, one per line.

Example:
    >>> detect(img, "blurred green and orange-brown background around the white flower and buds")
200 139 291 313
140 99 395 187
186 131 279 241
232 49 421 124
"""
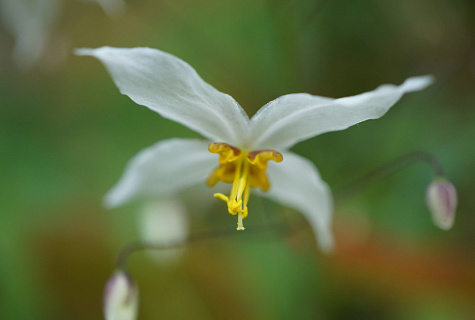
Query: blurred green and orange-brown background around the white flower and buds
0 0 475 320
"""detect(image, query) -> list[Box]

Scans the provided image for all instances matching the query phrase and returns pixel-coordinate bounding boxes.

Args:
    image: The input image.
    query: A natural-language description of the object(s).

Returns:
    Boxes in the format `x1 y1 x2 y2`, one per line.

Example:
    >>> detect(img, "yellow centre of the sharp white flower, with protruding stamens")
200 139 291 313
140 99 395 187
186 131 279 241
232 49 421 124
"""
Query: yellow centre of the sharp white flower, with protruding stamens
206 142 283 230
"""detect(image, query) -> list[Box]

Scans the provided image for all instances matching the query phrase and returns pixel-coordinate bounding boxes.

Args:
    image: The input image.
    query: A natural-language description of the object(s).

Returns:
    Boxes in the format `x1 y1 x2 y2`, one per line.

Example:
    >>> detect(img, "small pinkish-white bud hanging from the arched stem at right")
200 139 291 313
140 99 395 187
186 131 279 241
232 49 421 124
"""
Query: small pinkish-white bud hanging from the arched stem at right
426 177 457 230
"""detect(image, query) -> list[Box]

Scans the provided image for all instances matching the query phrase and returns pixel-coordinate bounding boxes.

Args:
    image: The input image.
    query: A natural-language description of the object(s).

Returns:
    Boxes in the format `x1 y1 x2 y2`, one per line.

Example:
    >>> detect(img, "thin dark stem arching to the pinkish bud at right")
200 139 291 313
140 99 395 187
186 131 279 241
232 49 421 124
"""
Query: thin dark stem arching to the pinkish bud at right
334 151 444 199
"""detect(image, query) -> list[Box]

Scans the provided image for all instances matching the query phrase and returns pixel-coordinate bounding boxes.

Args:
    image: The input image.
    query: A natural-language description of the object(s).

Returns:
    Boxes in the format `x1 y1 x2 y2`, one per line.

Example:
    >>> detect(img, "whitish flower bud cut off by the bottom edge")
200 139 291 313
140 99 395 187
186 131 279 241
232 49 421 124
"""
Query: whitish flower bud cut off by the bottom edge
104 270 139 320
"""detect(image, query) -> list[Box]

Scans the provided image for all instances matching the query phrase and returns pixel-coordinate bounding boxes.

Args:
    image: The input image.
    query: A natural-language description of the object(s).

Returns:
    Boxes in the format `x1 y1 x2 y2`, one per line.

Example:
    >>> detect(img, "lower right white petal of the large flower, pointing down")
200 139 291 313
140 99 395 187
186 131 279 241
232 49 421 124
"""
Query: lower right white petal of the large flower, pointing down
262 152 333 252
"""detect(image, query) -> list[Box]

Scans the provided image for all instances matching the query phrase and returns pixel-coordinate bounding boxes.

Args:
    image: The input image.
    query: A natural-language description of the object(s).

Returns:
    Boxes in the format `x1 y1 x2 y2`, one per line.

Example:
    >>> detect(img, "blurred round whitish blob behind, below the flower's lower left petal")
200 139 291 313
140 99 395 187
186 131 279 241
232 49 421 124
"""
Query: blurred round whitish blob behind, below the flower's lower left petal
140 196 188 263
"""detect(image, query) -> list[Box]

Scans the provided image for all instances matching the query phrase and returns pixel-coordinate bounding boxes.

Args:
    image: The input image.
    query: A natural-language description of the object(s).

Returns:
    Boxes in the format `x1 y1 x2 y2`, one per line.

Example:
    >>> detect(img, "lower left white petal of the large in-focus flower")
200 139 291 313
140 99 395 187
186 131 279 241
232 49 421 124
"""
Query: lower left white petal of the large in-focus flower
104 139 217 207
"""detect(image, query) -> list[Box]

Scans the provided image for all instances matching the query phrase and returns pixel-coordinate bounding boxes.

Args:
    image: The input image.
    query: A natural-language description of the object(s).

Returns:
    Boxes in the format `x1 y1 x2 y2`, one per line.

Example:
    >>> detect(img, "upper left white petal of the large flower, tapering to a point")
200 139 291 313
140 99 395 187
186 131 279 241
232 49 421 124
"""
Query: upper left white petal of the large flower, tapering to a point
76 47 249 145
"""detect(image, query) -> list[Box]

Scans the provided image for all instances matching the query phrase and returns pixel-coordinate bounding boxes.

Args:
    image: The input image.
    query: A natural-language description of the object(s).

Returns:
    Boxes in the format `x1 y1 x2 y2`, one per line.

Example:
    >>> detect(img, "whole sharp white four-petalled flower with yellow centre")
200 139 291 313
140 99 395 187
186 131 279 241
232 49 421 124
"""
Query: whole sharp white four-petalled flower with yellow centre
76 47 432 250
